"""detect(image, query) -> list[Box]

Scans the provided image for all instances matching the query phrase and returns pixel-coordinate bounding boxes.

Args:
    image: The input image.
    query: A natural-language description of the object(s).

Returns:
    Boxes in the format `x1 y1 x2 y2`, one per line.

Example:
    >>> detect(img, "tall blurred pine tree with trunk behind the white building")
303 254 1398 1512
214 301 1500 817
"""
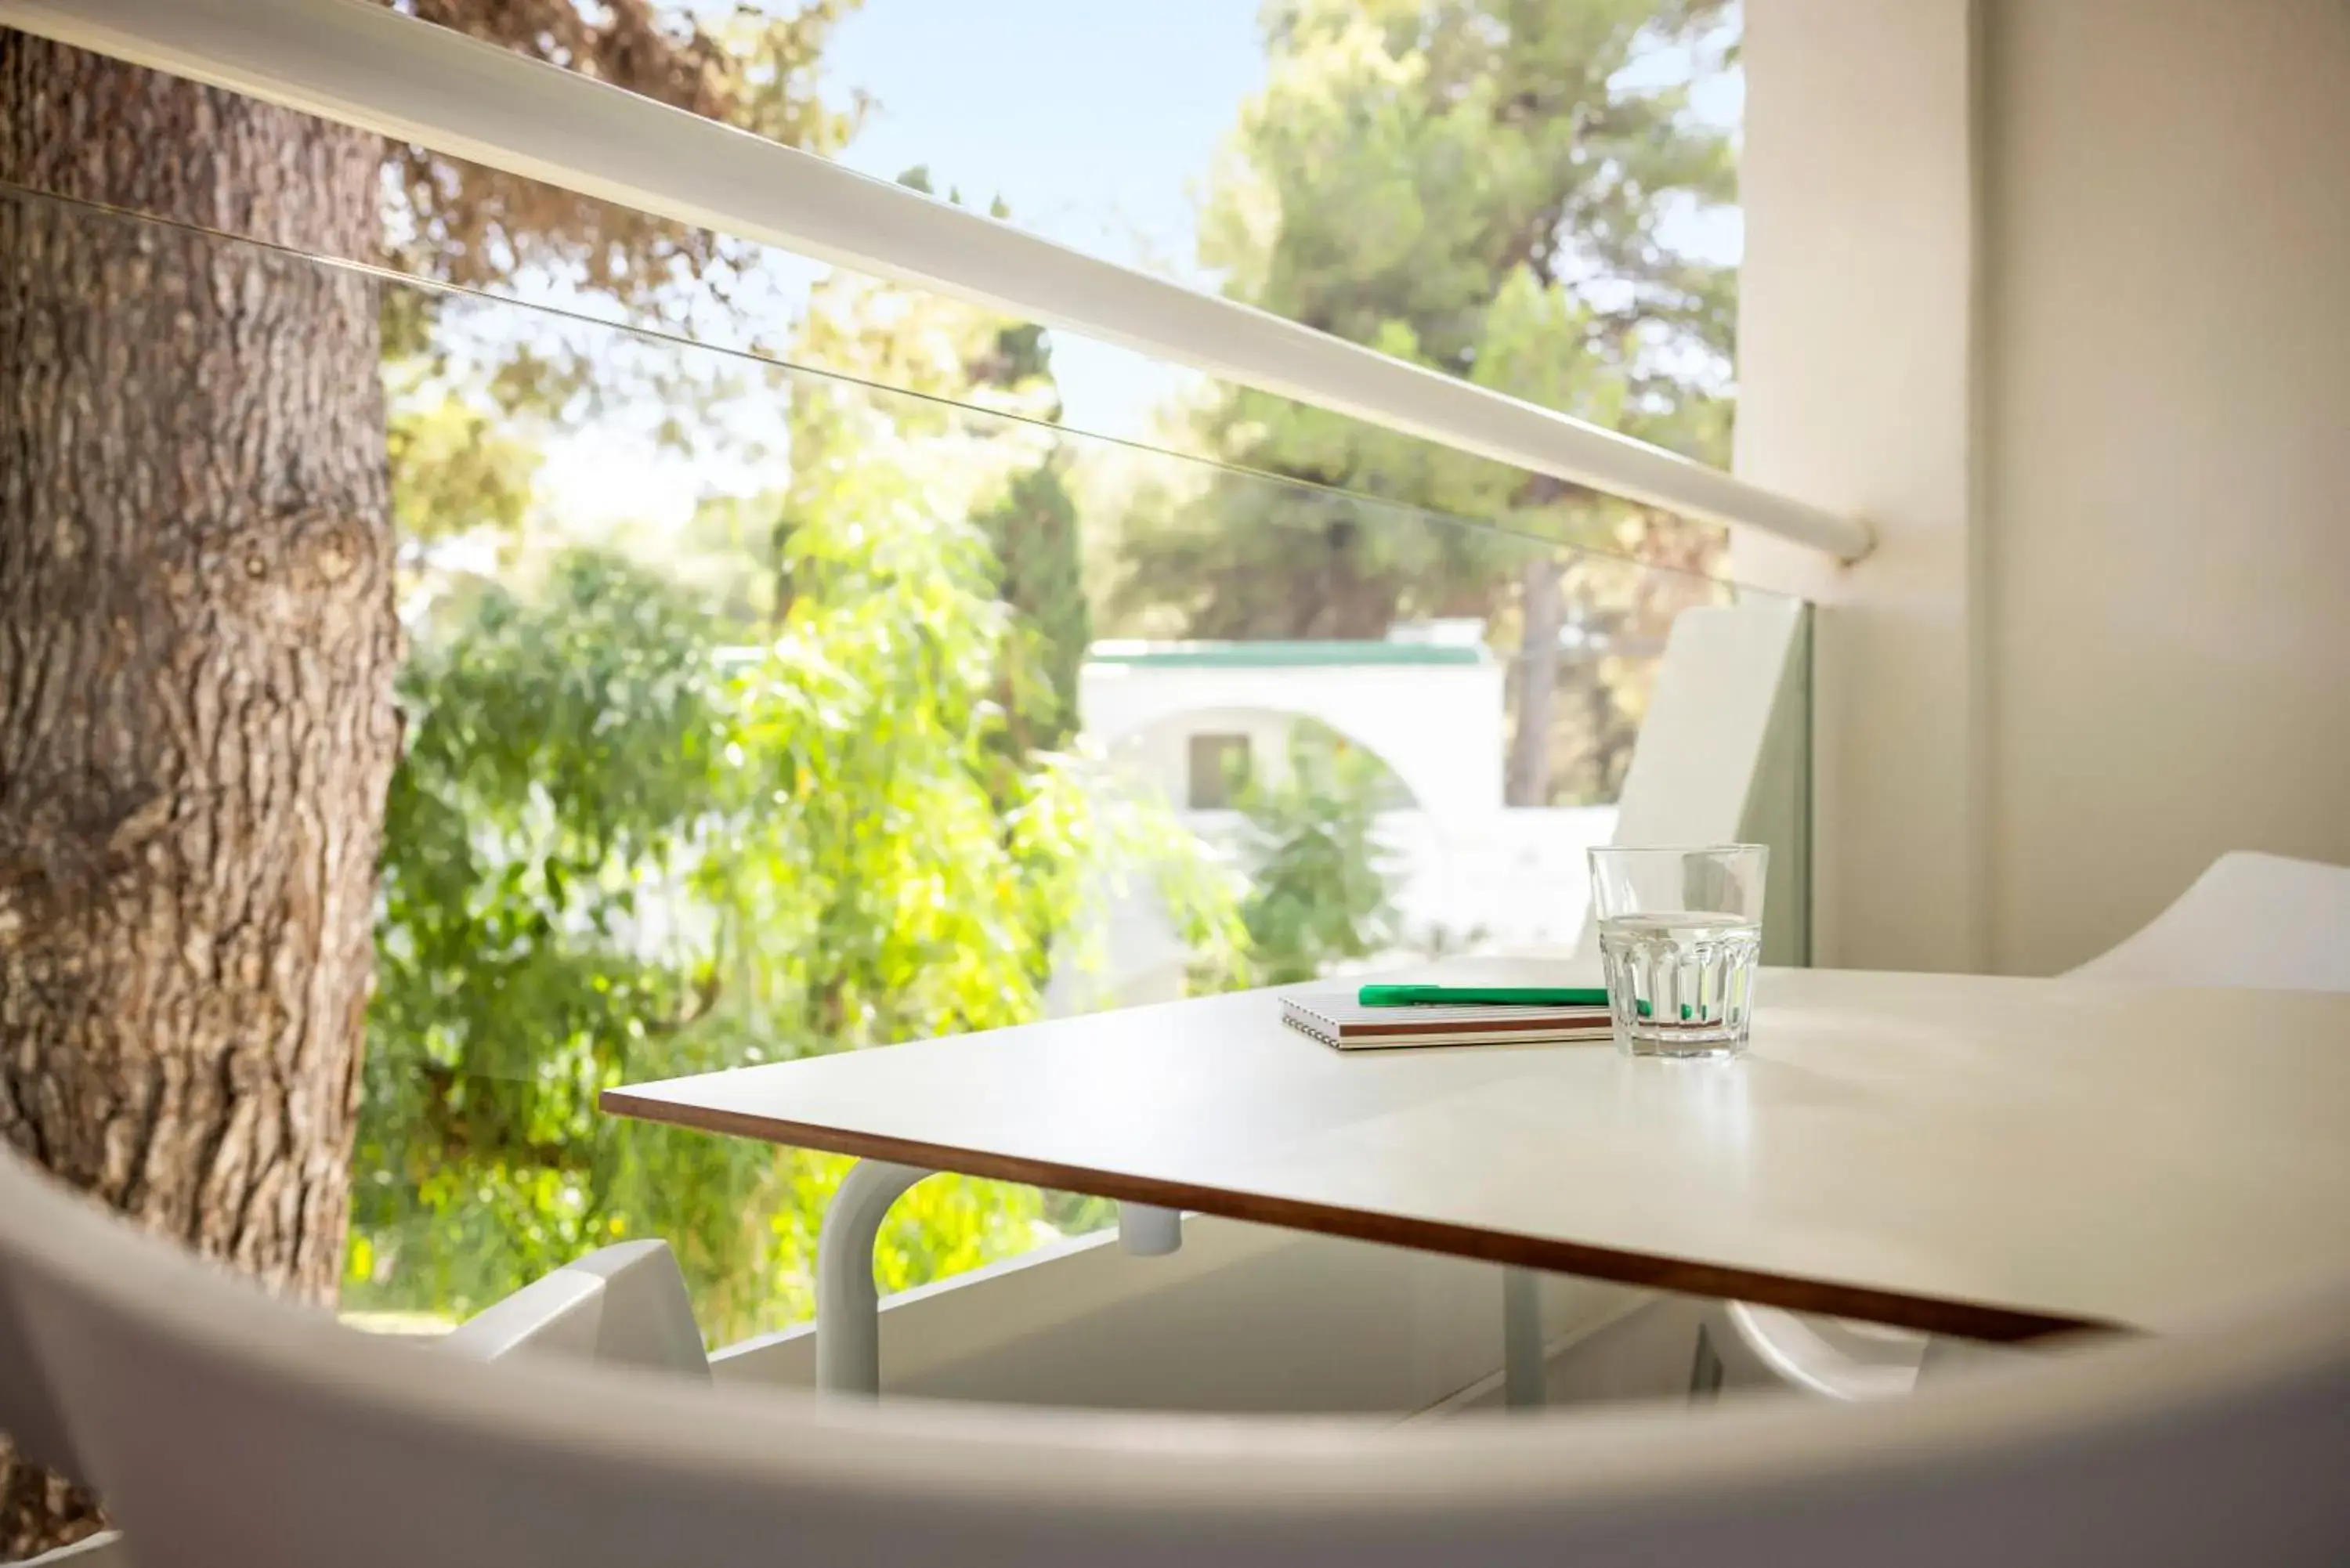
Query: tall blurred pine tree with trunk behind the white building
1114 0 1734 804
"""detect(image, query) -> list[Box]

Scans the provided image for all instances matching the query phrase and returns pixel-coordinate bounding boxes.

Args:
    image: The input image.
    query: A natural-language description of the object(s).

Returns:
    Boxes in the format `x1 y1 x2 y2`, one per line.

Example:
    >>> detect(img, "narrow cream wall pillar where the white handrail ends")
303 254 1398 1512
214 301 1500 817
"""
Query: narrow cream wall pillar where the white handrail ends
1732 0 1986 969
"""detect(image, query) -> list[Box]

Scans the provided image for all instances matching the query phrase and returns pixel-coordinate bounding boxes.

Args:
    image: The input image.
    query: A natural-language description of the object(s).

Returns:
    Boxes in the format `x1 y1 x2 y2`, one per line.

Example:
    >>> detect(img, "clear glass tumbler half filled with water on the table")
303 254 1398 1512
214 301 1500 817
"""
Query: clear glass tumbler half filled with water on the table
1591 844 1770 1056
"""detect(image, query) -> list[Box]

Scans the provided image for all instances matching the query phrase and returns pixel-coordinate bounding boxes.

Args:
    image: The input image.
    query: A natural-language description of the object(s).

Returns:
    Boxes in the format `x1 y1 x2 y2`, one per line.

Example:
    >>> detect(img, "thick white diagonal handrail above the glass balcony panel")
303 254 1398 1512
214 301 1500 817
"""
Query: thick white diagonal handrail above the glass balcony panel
0 0 1871 562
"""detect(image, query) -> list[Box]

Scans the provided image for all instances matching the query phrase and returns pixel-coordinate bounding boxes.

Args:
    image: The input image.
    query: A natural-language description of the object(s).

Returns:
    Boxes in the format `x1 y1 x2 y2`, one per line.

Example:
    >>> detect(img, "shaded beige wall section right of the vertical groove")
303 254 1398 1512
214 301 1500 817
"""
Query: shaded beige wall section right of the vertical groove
1986 0 2350 971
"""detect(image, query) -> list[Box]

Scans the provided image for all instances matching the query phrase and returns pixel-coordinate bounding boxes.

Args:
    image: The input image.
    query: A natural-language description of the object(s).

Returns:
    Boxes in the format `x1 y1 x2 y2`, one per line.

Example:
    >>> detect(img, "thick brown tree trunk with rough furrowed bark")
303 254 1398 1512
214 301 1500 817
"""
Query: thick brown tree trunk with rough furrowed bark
0 31 400 1556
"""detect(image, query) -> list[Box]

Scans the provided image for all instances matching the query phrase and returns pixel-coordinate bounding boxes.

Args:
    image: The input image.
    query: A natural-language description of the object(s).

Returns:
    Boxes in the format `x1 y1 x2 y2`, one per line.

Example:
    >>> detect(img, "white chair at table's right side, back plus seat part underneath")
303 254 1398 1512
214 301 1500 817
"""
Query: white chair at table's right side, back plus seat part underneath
1720 851 2350 1399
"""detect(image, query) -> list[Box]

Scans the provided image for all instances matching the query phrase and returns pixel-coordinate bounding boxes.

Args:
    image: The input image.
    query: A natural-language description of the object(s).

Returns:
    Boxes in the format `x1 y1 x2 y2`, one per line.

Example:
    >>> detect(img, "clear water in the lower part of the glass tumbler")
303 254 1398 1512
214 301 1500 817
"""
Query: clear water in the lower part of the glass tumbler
1600 910 1762 1056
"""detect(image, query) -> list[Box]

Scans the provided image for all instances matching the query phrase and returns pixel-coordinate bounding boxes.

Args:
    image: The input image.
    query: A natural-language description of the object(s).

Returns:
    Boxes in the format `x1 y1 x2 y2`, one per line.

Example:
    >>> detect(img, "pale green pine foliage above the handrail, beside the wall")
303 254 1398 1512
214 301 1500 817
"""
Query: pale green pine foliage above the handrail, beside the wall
1231 0 1734 388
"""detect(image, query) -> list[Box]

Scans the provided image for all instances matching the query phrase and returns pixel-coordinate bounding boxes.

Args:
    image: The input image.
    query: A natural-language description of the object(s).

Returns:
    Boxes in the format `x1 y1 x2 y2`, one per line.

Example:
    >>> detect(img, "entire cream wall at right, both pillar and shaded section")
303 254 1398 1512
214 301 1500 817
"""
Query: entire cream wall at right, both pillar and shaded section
1737 0 2350 974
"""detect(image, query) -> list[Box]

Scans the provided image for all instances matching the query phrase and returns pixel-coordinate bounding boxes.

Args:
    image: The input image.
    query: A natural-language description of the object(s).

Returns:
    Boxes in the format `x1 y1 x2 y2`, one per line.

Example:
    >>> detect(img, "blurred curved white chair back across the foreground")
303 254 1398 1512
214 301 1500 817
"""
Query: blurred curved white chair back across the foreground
0 1133 2350 1568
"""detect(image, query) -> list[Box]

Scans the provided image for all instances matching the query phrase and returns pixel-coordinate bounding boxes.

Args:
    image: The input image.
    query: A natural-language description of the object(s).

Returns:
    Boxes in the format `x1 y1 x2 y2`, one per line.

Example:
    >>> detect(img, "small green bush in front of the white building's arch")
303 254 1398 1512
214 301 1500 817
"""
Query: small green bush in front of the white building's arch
1236 724 1398 985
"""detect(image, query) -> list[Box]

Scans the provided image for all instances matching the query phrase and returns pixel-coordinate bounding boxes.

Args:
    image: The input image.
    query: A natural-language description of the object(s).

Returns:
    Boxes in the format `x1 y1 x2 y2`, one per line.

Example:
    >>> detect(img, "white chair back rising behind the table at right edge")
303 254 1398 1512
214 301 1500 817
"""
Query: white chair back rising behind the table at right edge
2070 851 2350 992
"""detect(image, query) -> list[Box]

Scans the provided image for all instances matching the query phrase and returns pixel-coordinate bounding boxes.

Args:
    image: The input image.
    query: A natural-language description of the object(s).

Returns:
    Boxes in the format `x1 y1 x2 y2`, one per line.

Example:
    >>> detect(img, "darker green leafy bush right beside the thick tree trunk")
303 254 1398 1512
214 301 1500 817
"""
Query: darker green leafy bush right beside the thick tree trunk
345 557 759 1317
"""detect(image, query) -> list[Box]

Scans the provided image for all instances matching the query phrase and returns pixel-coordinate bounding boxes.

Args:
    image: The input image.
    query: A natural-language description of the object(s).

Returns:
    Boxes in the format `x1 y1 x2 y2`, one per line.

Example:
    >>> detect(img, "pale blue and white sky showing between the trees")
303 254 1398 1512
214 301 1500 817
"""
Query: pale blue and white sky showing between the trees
550 0 1744 517
